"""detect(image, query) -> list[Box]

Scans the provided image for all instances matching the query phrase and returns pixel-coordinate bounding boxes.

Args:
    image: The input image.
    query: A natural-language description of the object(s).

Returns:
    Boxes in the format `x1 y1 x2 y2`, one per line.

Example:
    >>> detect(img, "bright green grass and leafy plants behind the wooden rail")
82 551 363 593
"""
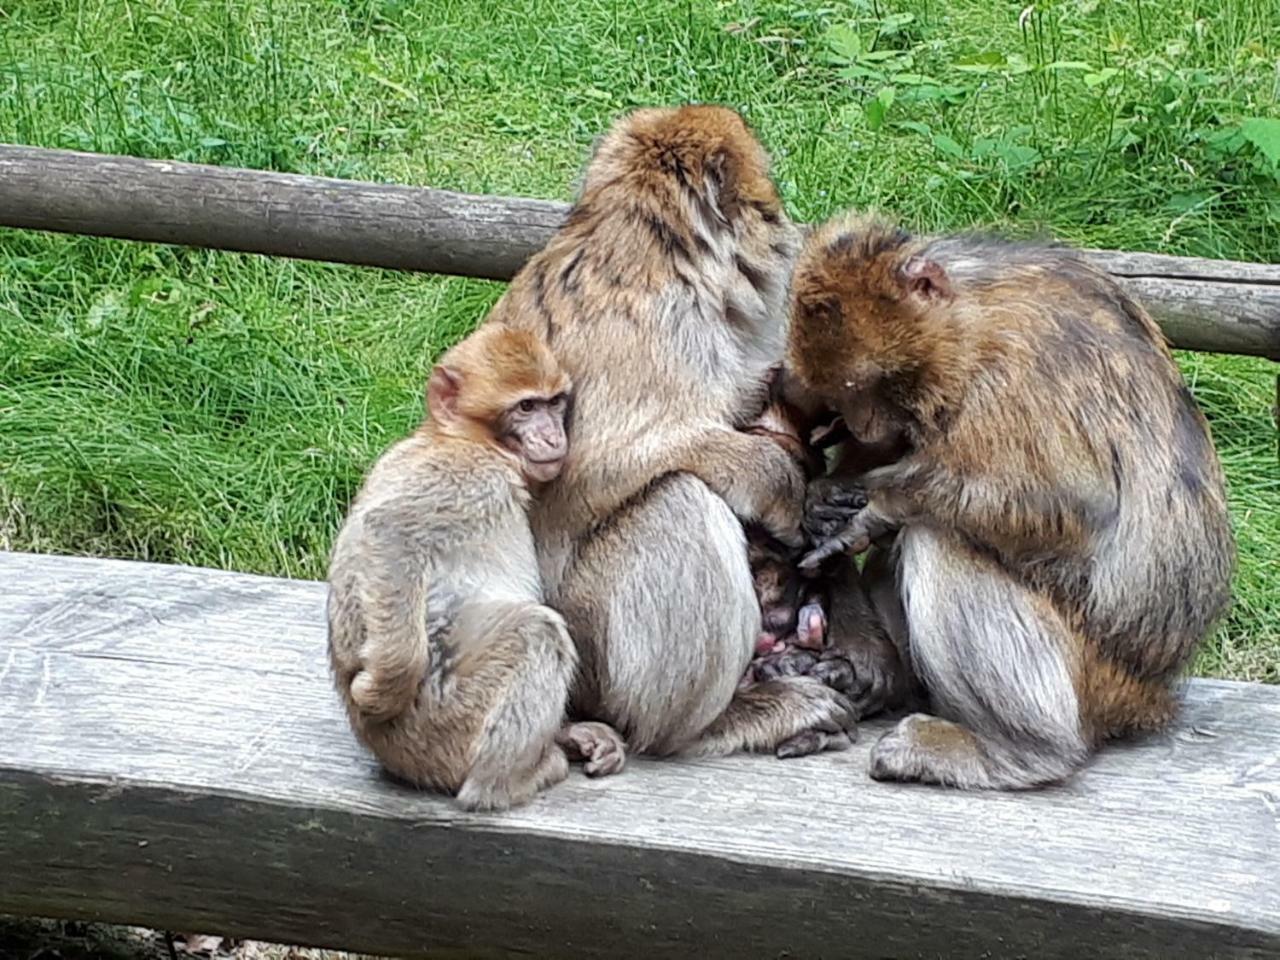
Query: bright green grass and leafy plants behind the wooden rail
0 0 1280 681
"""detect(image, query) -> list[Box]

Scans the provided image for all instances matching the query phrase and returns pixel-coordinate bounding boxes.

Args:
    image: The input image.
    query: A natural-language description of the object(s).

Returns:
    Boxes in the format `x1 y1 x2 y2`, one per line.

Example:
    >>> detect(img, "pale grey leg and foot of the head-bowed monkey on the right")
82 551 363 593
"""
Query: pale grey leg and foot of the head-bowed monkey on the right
870 527 1089 790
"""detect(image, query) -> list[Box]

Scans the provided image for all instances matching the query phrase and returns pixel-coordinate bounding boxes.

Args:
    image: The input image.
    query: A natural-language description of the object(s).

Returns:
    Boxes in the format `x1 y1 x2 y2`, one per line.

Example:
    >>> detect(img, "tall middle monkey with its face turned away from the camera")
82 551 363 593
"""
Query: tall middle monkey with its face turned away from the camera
492 106 855 754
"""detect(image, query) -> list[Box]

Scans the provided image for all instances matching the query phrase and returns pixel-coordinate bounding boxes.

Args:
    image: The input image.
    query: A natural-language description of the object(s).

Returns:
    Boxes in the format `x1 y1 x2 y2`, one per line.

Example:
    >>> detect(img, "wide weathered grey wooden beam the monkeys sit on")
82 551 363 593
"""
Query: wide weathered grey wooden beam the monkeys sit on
0 553 1280 960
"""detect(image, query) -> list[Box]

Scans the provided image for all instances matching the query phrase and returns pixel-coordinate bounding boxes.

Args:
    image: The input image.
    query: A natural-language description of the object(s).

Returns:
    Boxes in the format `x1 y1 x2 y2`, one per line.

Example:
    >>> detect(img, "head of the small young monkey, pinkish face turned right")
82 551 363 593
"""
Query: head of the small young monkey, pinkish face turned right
426 323 572 484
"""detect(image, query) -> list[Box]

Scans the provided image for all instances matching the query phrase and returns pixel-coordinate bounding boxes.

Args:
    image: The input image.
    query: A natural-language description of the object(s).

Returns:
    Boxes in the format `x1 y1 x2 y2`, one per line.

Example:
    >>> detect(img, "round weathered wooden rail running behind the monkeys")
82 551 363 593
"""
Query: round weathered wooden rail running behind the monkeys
0 145 1280 360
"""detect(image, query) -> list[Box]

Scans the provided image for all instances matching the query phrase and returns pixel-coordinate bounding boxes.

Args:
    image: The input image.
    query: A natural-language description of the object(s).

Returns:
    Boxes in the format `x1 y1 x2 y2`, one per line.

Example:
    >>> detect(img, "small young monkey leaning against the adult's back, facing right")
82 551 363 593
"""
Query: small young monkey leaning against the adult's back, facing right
329 324 623 809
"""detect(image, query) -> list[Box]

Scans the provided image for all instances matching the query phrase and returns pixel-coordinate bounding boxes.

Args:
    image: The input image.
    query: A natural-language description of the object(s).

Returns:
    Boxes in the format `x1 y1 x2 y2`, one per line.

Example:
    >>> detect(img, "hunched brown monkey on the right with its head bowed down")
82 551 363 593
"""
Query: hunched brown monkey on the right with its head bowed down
790 219 1234 788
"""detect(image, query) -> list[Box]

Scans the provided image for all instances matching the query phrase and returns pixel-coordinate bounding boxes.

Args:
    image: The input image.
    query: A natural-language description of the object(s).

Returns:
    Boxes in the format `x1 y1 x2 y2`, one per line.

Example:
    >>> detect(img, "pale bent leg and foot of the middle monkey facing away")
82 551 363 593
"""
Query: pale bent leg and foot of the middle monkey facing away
563 474 851 754
